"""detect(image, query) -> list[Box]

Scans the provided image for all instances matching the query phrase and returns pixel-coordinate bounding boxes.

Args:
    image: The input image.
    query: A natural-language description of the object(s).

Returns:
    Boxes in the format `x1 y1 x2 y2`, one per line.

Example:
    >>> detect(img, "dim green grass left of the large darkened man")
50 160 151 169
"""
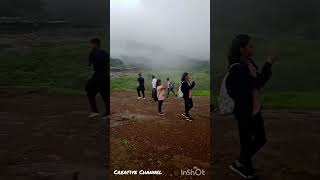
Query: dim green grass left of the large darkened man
0 41 95 90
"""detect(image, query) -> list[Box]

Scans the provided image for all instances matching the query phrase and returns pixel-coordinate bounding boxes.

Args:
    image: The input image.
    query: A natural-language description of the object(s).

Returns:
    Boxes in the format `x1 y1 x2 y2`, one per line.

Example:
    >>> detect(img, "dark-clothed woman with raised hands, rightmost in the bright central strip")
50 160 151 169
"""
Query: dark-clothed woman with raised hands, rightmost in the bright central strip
181 72 195 121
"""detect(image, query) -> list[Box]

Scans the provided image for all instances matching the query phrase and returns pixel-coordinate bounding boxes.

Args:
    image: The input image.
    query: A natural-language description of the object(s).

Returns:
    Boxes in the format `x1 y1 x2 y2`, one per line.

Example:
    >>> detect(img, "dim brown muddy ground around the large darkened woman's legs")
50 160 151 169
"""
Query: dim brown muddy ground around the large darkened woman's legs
212 110 320 180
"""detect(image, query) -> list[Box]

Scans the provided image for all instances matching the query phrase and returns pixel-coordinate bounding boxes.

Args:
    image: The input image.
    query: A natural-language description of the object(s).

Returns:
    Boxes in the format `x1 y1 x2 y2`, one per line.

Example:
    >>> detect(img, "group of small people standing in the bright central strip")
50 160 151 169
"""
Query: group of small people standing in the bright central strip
137 72 195 121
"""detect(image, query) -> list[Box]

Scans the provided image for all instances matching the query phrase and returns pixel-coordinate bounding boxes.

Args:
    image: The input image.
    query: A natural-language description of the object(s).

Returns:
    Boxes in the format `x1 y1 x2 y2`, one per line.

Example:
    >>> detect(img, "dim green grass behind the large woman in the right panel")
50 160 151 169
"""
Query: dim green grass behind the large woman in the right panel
211 33 320 110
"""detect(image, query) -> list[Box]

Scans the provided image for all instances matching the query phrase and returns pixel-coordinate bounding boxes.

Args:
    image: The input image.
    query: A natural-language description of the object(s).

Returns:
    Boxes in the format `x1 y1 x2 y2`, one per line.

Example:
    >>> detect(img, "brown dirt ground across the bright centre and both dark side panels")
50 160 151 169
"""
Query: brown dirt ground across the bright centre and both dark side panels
0 88 320 180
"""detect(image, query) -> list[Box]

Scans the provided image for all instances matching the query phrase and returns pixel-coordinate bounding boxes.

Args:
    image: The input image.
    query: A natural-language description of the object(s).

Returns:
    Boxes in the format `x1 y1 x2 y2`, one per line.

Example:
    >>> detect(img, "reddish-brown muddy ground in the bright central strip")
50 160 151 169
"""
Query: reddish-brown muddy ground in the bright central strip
110 92 210 179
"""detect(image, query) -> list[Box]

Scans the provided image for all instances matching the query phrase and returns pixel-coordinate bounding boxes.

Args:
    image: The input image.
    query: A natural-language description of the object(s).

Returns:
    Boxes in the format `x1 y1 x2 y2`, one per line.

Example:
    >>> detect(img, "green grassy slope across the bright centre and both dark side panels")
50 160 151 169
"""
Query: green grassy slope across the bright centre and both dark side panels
0 31 320 109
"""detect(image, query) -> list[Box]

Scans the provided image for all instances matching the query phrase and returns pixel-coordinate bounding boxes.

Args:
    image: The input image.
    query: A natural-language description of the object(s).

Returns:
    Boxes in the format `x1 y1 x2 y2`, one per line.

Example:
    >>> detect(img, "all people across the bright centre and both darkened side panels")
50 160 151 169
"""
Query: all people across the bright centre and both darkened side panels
86 34 274 179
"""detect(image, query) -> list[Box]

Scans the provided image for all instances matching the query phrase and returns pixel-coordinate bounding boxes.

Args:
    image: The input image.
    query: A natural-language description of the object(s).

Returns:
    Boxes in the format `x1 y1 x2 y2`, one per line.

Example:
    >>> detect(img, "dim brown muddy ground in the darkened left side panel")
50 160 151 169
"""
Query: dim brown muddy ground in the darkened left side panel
0 88 107 180
